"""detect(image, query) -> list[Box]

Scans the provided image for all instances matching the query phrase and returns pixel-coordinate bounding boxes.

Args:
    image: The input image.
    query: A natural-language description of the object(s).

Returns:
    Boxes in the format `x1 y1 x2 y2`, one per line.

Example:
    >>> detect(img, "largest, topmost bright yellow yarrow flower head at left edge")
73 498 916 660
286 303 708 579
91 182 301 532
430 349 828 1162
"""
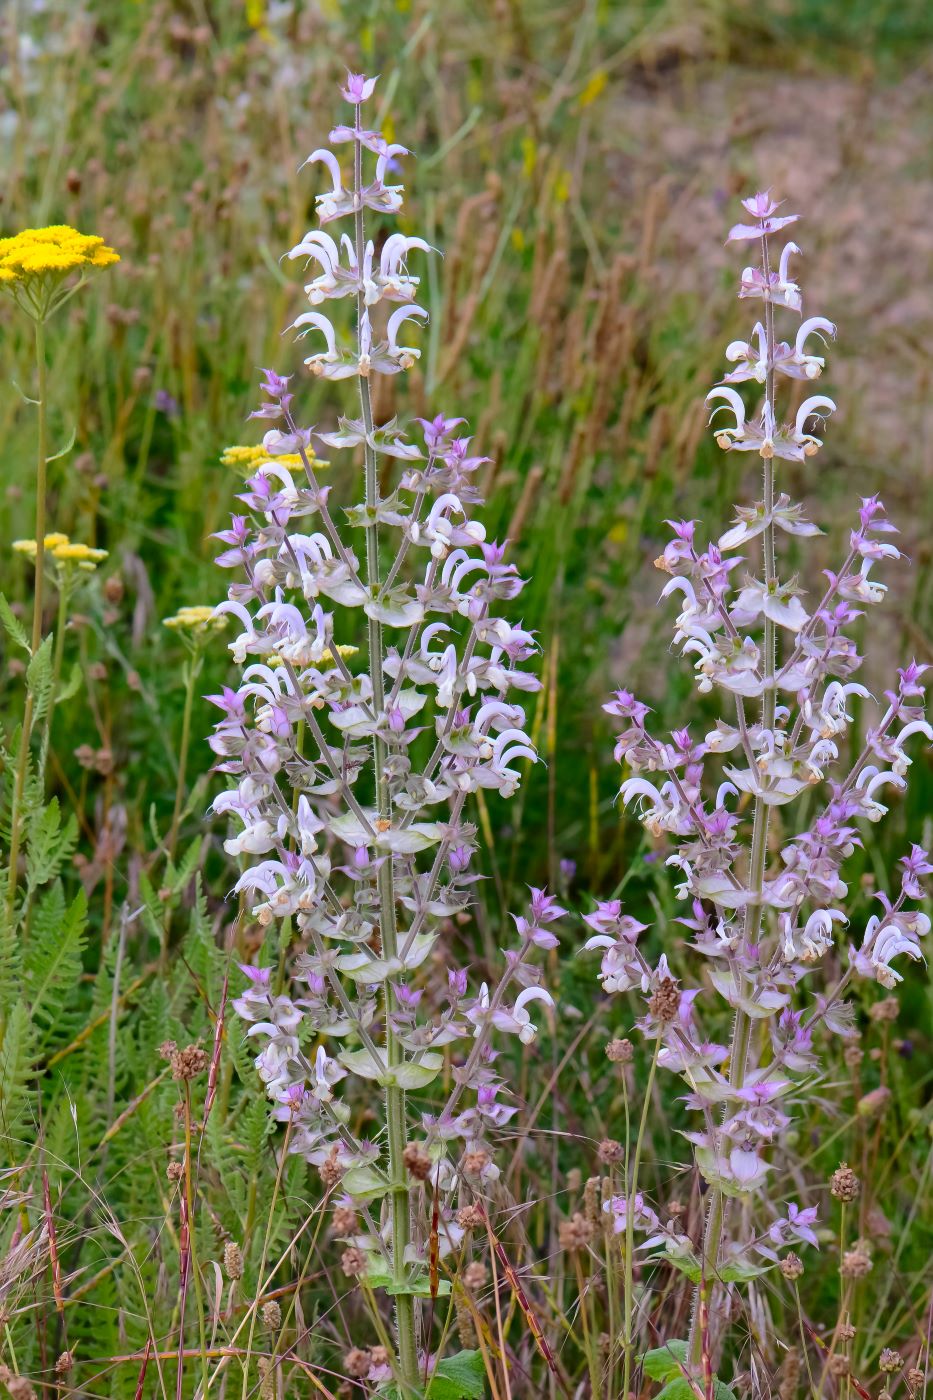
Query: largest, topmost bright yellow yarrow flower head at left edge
0 224 120 319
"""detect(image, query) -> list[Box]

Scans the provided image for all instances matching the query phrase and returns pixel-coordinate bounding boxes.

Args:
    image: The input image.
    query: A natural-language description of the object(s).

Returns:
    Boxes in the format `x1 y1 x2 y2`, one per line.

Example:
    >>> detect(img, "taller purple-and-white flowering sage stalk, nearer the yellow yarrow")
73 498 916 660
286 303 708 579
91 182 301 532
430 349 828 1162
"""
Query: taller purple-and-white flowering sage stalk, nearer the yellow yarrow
217 74 563 1393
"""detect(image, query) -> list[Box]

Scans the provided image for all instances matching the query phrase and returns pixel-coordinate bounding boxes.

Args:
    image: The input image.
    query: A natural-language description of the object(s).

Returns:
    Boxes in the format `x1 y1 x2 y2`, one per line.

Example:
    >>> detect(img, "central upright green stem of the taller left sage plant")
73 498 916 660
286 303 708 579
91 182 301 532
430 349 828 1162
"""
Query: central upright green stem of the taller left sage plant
353 106 417 1387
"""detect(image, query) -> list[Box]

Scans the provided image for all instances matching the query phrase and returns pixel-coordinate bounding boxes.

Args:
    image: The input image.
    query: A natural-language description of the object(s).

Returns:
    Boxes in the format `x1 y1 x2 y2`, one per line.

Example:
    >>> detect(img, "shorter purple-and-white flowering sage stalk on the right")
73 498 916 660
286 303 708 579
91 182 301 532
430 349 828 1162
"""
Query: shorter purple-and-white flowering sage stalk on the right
587 195 933 1378
